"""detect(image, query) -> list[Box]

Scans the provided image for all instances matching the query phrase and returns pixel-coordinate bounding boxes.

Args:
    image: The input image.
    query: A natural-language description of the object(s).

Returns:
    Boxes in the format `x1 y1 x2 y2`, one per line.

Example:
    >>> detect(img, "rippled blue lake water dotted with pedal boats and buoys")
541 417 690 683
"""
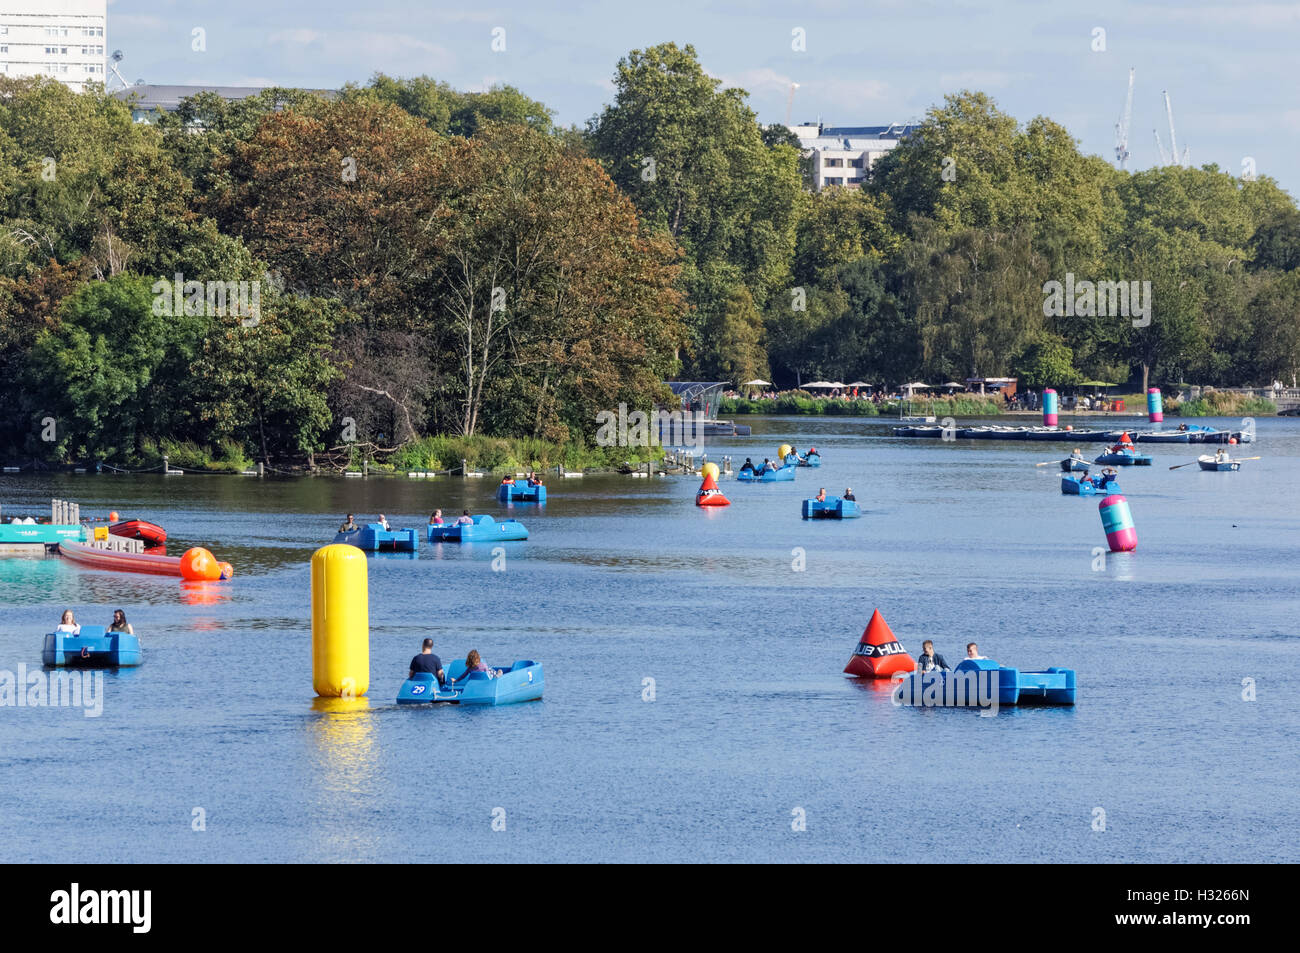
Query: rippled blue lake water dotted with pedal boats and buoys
0 417 1300 862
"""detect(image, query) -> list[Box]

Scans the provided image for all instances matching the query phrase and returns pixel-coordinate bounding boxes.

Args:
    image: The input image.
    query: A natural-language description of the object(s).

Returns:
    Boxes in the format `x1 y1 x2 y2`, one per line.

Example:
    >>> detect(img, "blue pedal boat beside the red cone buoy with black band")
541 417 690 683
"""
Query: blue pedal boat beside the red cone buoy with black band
901 658 1078 707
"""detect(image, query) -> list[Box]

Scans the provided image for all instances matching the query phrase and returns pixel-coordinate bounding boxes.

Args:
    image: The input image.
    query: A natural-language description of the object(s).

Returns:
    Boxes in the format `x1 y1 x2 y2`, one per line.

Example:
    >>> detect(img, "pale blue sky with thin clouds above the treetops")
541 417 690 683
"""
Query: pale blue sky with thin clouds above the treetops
109 0 1300 195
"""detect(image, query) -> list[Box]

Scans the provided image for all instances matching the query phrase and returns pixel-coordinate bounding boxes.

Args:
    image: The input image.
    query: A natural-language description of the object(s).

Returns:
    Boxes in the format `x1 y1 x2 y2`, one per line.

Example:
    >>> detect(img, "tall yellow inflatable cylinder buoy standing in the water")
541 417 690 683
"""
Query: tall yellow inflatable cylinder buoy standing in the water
312 543 371 698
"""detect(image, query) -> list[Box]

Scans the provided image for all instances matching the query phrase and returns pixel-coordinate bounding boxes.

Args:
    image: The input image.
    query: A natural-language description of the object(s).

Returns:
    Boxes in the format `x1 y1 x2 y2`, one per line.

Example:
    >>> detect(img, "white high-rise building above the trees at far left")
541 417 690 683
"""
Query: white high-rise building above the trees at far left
0 0 108 92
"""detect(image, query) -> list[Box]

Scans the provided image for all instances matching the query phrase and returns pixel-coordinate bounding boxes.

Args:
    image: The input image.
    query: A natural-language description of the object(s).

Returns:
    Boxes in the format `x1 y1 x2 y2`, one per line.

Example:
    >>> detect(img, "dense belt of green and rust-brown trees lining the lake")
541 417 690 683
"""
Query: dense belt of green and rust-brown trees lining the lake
0 43 1300 469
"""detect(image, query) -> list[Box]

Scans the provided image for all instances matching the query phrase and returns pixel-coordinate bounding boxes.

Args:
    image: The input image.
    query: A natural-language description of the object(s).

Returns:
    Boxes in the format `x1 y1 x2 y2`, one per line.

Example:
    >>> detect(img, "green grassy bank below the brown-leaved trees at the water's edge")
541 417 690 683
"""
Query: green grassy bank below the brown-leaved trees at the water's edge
377 436 663 471
